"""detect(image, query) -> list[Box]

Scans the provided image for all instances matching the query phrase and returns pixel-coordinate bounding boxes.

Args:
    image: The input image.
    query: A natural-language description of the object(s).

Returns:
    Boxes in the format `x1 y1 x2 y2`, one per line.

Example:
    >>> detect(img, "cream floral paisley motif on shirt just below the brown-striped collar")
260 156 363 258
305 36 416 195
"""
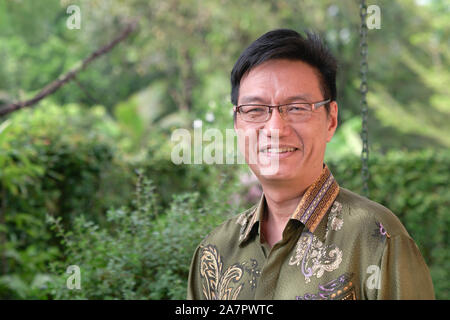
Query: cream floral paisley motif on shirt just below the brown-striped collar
289 232 342 283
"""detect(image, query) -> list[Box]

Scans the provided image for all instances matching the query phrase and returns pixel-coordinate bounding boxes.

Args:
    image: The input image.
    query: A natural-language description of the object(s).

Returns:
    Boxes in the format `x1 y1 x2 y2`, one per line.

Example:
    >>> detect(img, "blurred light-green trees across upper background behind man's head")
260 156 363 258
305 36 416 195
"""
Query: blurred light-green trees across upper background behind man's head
0 0 450 151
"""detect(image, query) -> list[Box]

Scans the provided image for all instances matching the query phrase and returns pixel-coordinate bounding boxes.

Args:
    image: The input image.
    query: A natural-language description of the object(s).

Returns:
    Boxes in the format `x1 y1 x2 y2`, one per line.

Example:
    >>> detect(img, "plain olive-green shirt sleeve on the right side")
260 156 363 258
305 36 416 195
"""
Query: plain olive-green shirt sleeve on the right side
377 235 435 300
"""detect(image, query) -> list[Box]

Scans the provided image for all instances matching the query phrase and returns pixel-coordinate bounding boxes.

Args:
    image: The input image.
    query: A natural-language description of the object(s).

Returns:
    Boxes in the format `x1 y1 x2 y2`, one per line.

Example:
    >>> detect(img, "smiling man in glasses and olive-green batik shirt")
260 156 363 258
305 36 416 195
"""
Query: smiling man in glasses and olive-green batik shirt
188 29 434 300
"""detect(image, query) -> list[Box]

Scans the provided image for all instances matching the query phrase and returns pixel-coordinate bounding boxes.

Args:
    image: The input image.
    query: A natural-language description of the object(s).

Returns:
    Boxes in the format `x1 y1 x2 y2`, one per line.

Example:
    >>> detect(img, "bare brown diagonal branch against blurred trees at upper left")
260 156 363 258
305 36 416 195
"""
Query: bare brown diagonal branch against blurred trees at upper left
0 22 137 117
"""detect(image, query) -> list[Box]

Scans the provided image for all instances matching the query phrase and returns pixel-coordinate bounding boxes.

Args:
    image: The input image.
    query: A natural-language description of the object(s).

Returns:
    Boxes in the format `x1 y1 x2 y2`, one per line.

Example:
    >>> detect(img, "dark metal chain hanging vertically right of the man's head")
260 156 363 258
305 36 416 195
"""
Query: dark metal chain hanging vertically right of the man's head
359 0 369 197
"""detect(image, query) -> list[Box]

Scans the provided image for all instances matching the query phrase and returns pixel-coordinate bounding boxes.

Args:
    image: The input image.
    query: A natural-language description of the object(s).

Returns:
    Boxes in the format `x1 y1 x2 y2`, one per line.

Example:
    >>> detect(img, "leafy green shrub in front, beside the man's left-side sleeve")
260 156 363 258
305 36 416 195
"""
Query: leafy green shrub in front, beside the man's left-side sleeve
45 171 238 299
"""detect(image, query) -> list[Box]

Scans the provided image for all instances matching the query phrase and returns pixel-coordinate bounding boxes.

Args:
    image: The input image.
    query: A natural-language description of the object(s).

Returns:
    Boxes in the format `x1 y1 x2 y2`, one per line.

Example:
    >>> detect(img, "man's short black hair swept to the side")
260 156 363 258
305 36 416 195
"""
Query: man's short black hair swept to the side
231 29 337 112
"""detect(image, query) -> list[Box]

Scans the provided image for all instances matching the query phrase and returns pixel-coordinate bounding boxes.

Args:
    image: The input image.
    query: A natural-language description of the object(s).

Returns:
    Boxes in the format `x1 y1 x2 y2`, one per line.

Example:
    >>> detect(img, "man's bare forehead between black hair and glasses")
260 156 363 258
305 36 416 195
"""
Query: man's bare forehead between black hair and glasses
239 60 322 103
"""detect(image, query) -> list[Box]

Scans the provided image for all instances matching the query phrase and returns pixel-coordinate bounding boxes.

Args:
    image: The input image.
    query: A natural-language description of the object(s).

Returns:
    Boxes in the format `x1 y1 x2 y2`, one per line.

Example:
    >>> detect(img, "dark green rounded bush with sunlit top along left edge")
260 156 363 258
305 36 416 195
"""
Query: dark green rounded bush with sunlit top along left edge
0 103 132 298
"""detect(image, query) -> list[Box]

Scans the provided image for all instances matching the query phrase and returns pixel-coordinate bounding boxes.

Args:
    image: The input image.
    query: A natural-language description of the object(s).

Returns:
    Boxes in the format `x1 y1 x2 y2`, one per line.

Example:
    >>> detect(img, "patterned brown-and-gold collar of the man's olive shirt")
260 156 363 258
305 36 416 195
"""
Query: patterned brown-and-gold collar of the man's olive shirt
238 164 339 244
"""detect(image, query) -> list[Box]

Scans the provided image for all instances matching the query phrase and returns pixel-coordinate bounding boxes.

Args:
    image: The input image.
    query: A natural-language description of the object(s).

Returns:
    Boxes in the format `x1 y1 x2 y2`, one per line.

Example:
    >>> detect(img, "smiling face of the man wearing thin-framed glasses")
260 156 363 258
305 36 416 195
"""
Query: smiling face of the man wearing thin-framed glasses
234 60 338 183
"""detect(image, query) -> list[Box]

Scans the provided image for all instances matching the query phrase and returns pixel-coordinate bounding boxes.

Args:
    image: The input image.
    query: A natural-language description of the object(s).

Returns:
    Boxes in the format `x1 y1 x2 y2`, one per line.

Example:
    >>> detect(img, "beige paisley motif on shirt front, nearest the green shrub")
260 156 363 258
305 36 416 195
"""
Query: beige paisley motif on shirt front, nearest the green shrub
200 244 261 300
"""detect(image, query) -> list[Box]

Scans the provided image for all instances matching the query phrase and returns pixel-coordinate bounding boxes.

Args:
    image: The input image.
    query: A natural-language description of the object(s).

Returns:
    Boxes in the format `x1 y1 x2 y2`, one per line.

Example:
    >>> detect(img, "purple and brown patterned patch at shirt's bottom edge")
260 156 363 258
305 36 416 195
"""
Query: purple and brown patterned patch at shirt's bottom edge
296 272 356 300
